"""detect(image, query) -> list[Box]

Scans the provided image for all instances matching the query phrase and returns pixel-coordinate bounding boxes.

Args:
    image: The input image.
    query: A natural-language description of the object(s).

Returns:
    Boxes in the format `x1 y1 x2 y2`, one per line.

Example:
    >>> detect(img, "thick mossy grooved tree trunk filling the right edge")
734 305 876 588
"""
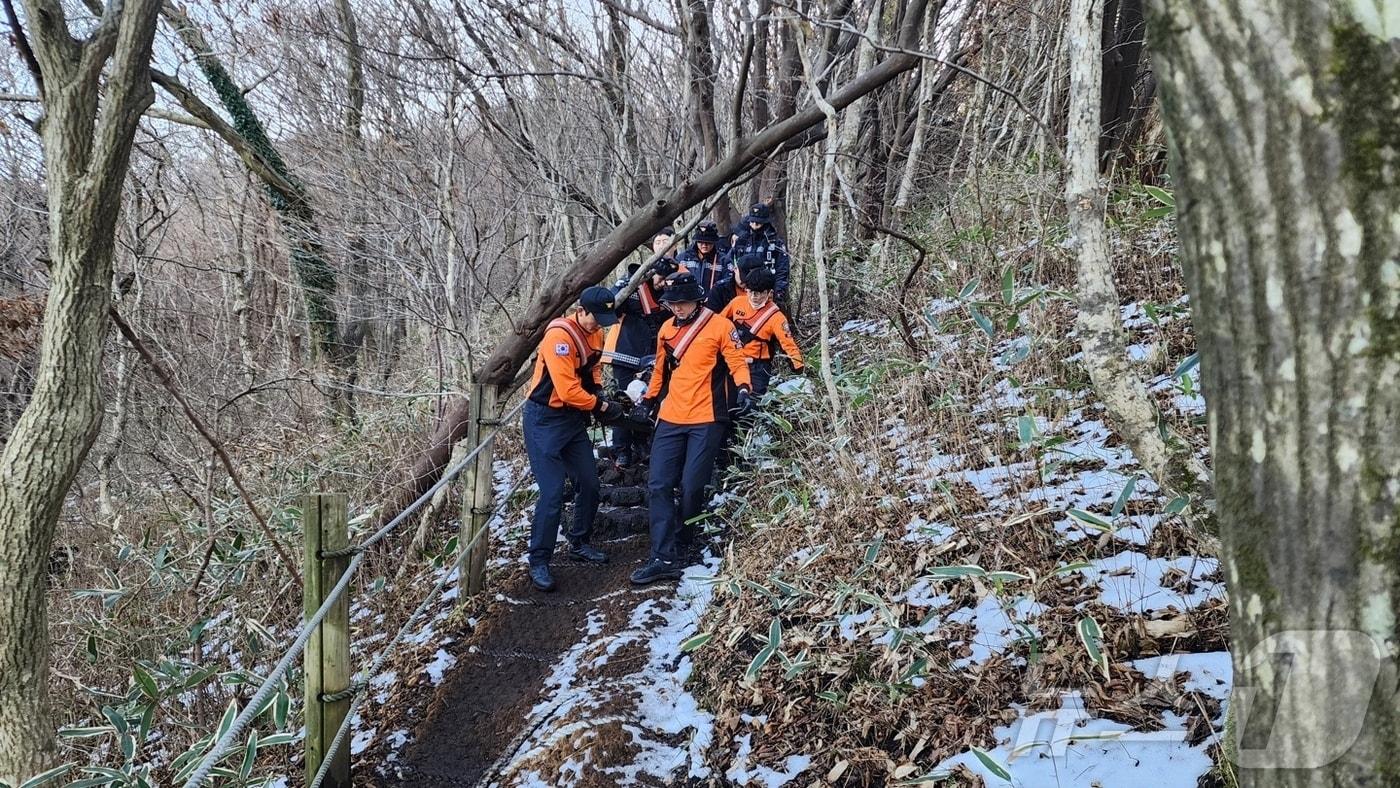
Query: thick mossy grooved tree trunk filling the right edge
1149 0 1400 785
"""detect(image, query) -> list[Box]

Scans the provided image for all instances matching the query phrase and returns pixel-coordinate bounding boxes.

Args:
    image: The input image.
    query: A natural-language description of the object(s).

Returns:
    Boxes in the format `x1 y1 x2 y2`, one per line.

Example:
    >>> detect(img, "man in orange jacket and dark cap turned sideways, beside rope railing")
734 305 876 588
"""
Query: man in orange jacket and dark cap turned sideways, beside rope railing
525 287 622 591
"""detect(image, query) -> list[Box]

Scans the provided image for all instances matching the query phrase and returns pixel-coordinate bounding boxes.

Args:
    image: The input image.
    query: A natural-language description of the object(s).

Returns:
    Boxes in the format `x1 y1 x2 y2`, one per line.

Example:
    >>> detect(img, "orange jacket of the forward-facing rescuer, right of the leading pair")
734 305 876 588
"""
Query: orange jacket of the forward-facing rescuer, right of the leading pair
647 307 749 424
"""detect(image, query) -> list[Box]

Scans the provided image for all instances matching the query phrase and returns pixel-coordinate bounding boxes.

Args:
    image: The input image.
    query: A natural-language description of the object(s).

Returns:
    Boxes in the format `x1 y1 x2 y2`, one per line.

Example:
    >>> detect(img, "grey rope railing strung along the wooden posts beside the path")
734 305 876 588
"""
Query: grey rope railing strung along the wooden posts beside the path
185 400 528 788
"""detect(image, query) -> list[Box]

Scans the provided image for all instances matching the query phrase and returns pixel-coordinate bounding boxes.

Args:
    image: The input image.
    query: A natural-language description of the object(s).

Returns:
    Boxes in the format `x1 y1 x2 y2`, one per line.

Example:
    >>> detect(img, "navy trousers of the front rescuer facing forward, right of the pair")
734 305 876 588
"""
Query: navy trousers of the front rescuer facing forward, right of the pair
647 421 728 561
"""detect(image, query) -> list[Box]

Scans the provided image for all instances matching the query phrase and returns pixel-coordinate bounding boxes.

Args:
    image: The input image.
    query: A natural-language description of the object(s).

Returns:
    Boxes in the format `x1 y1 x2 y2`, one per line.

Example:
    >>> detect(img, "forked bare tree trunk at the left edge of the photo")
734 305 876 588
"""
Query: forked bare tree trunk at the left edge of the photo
0 0 160 785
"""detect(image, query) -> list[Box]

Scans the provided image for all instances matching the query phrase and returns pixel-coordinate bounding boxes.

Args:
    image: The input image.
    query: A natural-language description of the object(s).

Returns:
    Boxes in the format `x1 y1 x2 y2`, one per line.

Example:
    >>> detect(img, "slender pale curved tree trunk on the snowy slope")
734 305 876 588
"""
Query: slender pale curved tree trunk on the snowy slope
1065 0 1211 532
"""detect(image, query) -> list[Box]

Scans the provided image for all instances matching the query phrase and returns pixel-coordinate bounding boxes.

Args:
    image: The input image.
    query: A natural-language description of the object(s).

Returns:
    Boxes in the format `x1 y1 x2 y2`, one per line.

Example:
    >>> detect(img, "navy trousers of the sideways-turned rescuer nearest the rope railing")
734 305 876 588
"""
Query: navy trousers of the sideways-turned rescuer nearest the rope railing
525 400 598 565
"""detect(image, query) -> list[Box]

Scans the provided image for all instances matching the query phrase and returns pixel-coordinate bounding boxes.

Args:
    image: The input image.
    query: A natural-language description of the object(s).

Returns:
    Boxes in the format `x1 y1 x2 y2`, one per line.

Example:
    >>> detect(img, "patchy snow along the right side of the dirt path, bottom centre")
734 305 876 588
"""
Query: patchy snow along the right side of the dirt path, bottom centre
494 556 728 787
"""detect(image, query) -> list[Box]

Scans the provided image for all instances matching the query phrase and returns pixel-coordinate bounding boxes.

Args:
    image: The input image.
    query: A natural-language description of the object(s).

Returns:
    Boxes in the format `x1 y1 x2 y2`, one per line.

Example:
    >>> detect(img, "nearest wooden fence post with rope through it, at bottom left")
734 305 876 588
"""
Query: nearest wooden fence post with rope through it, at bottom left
301 493 350 788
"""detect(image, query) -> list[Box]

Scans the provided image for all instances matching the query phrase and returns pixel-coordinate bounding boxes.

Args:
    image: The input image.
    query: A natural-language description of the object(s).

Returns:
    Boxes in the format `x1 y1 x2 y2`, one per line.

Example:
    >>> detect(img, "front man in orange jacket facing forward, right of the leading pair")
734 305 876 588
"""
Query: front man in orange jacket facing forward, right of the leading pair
631 272 752 584
